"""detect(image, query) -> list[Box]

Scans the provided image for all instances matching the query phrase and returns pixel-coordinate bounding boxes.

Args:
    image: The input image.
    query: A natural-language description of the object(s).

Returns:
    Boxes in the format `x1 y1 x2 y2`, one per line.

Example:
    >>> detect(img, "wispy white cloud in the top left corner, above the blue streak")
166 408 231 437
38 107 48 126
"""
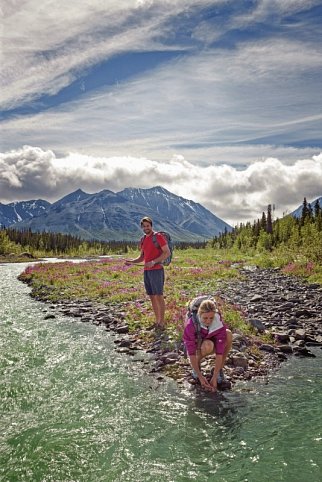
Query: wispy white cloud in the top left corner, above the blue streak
1 0 216 108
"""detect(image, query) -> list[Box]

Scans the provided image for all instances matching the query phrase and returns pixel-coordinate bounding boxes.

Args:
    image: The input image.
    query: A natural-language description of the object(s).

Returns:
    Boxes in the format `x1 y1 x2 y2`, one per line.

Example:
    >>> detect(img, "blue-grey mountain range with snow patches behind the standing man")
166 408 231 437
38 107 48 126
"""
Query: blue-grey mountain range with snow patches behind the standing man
0 186 232 242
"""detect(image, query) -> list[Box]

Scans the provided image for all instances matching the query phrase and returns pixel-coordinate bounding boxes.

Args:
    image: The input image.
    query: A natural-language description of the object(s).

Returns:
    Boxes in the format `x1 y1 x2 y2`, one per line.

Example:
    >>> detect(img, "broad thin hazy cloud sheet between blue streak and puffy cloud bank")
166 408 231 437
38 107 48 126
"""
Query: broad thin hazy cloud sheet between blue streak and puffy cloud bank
2 34 322 164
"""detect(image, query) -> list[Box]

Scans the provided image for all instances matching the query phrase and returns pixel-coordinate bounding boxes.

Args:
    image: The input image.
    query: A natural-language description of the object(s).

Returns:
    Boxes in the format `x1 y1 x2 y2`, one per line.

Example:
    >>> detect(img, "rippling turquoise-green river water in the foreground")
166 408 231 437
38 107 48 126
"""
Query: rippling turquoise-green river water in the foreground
0 264 322 482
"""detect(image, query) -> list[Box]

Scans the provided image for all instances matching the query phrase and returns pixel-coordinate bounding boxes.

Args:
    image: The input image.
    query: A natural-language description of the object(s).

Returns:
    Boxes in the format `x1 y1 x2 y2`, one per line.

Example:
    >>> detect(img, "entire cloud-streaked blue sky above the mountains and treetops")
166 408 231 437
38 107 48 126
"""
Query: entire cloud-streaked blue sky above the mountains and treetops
0 0 322 226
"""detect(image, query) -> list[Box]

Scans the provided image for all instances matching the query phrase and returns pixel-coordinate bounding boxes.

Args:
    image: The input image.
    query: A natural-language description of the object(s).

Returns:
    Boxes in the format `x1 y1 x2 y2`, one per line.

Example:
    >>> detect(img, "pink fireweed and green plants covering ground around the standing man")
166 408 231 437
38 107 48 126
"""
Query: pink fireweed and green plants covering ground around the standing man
19 250 242 339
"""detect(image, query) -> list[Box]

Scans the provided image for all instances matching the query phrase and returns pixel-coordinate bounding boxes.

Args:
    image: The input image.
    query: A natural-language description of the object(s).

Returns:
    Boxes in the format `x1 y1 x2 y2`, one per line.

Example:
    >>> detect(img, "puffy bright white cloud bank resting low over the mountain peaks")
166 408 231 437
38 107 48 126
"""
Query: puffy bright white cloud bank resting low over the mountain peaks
0 146 322 224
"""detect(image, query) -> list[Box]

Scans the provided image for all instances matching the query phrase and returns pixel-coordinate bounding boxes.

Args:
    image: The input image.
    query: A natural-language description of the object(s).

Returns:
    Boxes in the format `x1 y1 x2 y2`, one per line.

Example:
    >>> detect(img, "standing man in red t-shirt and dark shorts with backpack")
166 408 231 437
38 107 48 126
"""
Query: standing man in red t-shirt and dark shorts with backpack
125 216 170 330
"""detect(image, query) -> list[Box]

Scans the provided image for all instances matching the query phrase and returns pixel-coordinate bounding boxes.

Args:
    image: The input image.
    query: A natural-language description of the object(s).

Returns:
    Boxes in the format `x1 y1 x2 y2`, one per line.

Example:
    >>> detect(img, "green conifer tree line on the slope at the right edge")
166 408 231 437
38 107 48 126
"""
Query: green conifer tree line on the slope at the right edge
211 198 322 261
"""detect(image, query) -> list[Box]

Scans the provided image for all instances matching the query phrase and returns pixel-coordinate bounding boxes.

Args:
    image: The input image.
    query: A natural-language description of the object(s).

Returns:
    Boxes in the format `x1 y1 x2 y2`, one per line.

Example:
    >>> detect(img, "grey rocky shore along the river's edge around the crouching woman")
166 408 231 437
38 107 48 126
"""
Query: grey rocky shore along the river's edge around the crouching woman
35 267 322 390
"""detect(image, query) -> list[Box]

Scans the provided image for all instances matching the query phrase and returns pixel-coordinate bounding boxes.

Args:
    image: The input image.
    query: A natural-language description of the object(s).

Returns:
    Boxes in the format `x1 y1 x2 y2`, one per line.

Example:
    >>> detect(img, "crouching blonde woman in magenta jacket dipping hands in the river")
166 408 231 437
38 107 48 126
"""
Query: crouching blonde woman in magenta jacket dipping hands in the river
183 299 232 391
